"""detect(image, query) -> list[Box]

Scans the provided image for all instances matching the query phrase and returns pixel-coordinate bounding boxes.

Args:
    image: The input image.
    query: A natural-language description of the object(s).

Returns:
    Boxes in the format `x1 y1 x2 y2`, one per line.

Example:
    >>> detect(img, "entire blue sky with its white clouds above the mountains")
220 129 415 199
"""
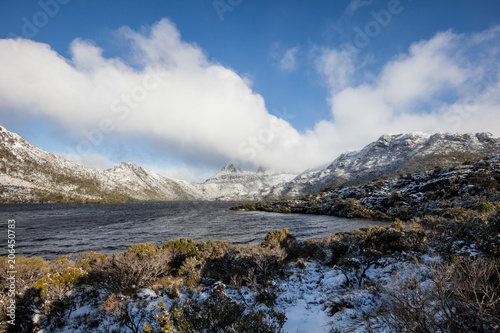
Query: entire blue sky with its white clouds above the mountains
0 0 500 182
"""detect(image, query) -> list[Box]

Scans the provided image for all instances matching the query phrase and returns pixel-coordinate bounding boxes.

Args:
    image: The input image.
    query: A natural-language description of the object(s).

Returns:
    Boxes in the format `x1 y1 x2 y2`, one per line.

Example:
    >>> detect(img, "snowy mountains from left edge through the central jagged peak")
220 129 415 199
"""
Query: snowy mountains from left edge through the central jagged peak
0 126 296 203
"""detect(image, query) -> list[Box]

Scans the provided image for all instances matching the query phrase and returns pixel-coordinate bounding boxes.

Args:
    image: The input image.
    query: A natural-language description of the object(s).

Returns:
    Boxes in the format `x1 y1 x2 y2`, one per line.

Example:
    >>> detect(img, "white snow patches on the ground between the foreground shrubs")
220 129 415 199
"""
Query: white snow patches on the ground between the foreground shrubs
41 254 435 333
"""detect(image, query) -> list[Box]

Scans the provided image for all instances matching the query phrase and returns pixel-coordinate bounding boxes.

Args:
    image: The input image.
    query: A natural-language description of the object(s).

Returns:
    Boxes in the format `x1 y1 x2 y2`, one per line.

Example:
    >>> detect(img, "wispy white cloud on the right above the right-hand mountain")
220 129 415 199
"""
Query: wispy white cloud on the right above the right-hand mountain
317 27 500 149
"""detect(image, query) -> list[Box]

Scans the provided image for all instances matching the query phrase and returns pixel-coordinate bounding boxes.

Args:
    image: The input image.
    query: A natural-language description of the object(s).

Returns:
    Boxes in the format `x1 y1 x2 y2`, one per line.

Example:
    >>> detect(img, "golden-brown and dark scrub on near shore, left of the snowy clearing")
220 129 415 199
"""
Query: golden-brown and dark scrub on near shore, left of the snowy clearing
0 230 297 332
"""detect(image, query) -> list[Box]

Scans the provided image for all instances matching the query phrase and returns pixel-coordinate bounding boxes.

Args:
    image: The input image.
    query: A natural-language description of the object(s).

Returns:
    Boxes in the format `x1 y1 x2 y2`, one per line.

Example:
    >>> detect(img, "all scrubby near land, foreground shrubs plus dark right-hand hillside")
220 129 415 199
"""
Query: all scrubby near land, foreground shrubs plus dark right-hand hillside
0 161 500 332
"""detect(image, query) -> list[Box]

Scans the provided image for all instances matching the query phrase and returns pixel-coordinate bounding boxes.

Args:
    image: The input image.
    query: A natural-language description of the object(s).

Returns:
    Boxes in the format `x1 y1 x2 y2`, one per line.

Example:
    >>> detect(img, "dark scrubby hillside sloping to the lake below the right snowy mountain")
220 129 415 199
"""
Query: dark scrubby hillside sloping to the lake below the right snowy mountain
233 157 500 220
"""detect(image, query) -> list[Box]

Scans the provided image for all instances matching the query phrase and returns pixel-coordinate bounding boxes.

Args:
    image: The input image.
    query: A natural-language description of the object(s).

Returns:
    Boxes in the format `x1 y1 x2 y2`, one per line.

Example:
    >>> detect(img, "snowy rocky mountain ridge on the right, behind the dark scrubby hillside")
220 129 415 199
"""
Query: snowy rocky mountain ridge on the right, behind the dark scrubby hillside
269 132 500 198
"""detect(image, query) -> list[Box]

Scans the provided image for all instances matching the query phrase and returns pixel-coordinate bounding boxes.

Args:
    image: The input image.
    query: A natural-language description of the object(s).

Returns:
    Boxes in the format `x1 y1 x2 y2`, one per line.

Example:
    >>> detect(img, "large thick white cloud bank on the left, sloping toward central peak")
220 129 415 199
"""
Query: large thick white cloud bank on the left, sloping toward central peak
0 19 331 172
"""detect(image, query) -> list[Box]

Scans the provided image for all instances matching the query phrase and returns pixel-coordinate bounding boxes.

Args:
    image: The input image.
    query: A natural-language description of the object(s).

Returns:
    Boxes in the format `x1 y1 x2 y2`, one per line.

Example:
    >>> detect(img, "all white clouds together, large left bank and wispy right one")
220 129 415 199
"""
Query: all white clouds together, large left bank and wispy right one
0 19 500 179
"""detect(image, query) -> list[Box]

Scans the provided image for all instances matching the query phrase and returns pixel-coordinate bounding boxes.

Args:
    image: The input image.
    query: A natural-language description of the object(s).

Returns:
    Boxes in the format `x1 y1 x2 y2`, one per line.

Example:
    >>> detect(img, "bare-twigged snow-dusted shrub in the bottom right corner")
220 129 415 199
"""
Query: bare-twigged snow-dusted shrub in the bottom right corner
376 257 500 332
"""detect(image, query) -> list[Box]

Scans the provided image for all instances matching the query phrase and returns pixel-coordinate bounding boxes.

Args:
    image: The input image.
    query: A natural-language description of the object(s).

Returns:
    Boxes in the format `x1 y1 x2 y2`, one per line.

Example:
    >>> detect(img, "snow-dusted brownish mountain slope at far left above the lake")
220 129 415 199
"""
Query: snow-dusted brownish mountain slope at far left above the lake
0 126 204 203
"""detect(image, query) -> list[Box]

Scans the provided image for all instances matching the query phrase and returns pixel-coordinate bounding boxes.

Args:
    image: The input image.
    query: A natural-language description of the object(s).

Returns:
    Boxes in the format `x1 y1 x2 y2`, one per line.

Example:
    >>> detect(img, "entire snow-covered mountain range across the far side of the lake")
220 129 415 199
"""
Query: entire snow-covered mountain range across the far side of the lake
0 126 500 203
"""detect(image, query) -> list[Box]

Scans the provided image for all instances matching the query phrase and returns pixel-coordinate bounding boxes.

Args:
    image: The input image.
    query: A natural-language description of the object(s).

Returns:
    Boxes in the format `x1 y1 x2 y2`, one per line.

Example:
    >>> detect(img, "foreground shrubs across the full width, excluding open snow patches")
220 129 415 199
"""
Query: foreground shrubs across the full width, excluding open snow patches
1 207 500 332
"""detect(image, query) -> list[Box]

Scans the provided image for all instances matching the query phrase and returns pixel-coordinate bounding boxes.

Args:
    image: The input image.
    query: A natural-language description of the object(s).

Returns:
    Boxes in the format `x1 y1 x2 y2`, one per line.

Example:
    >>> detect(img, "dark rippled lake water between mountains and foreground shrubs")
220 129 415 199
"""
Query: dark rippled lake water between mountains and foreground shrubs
0 201 387 259
